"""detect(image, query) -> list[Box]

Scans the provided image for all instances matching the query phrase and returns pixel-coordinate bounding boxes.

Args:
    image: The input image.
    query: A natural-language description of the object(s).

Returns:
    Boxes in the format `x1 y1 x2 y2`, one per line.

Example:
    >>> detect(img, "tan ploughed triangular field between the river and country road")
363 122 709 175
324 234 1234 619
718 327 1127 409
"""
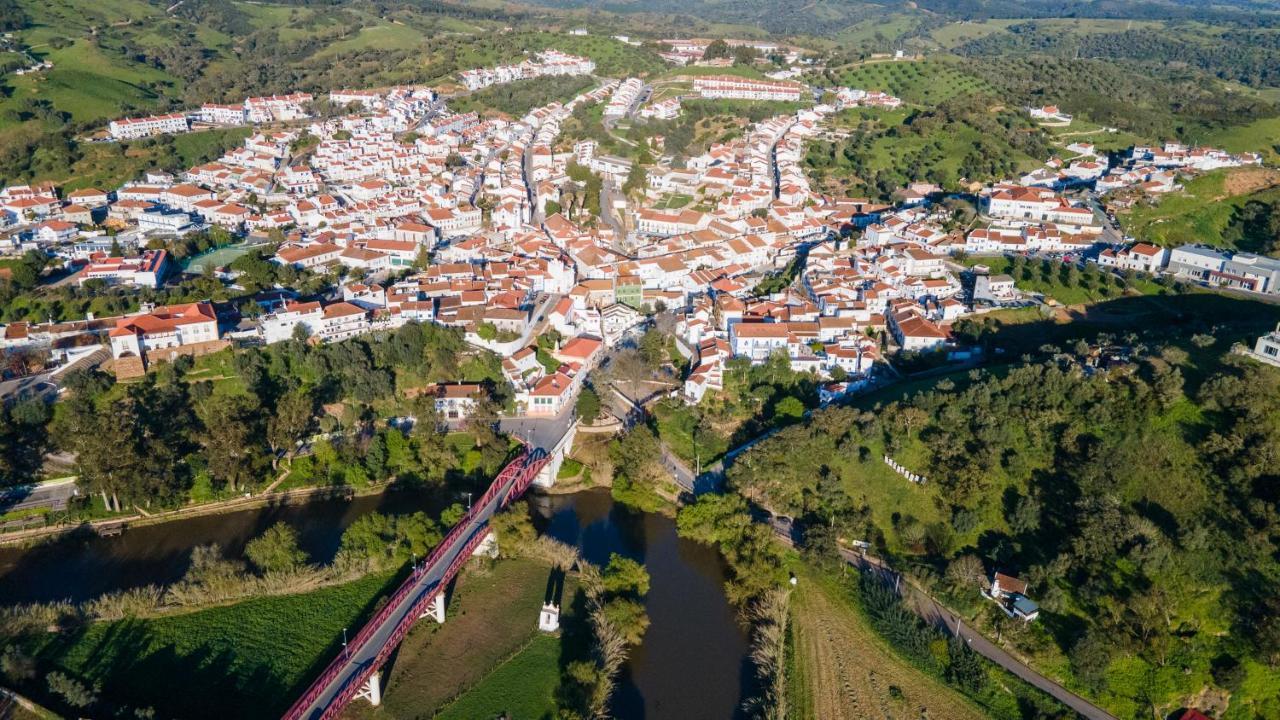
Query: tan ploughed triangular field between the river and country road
792 566 983 720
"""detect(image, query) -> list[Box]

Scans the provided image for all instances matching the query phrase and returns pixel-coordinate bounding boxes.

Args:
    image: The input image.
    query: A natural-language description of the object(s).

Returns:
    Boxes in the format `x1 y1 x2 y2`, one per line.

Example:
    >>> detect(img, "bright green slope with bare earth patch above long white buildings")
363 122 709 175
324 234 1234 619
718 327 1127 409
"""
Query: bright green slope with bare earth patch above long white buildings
1120 168 1280 247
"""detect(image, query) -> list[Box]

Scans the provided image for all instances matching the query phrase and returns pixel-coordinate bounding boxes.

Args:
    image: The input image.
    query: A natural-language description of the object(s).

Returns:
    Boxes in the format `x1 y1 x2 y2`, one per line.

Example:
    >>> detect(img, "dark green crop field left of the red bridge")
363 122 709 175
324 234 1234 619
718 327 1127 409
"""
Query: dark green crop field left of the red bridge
24 574 394 717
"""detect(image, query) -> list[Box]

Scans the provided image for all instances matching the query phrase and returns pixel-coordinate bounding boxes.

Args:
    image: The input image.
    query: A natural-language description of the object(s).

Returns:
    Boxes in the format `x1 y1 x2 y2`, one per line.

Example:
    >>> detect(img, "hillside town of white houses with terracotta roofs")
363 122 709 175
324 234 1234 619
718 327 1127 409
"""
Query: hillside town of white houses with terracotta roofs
0 44 1280 416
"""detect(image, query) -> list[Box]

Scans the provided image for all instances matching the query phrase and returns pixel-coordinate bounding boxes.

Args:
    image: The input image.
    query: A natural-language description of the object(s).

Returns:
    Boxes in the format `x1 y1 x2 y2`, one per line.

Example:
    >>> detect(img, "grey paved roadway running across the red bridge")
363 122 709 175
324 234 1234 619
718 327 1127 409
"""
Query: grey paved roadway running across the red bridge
289 453 535 719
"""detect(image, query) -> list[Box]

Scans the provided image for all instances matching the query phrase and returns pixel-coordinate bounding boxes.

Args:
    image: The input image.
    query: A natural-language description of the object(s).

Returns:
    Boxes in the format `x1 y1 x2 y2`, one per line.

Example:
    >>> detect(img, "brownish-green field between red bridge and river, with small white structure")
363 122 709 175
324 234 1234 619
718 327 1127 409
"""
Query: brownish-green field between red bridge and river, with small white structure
346 559 576 719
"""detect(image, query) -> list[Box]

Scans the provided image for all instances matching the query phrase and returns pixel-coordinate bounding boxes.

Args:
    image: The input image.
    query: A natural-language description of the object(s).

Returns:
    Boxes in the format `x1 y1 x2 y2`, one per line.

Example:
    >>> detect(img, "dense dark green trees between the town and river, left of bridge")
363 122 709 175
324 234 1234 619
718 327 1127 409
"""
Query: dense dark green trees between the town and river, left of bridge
0 324 508 510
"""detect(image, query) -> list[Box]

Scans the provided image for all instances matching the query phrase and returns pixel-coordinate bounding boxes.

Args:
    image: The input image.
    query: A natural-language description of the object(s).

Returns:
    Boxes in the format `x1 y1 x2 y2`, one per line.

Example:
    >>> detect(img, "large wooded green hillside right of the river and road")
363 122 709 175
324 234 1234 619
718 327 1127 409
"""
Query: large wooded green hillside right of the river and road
728 296 1280 717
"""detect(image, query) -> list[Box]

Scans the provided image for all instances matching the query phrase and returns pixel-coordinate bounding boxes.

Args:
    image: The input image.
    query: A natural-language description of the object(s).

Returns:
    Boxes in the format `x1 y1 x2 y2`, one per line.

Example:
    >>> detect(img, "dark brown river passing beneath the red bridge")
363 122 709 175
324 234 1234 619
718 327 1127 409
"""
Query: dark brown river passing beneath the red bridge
0 489 754 720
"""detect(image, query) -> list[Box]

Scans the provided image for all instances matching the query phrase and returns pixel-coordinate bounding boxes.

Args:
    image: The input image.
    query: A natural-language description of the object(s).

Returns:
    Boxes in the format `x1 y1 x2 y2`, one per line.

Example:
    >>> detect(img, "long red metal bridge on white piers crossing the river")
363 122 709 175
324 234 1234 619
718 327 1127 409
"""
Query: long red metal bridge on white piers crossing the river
284 448 549 720
